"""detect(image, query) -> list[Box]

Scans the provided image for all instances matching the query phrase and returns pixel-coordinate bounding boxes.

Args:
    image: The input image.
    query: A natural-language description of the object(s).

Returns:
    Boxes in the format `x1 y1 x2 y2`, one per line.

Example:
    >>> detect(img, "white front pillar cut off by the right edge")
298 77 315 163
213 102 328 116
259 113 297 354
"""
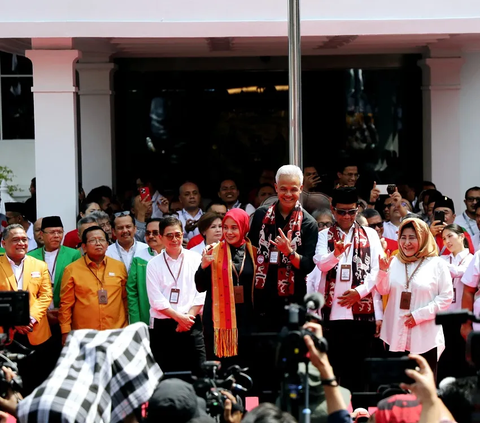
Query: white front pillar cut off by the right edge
457 51 480 197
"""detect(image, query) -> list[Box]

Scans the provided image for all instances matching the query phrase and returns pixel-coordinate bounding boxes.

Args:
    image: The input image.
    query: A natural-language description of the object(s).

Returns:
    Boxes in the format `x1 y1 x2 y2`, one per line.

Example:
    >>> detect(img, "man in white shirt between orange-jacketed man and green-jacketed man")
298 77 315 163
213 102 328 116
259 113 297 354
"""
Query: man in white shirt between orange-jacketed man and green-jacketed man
107 211 148 273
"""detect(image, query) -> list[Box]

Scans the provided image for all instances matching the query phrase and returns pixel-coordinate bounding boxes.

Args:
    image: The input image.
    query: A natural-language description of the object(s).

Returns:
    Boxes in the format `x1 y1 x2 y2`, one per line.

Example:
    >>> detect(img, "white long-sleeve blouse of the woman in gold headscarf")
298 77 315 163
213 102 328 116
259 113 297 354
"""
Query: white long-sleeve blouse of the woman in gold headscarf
377 257 453 359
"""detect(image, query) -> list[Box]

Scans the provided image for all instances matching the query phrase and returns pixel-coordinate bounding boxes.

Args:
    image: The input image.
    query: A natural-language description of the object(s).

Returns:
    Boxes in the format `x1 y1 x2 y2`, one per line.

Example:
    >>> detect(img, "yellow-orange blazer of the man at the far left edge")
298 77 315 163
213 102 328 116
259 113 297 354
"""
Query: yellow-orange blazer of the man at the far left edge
0 255 53 345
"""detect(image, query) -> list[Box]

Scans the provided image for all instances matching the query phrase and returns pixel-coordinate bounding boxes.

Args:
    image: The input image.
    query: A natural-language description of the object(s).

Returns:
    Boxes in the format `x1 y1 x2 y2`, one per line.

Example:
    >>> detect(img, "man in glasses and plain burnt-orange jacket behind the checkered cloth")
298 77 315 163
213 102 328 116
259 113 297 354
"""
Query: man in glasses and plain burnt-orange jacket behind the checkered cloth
58 226 128 344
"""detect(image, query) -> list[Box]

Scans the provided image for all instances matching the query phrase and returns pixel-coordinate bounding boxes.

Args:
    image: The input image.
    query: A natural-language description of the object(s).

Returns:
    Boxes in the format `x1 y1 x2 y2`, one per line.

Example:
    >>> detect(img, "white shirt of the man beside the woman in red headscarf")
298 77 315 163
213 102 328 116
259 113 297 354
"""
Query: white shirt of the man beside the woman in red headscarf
147 248 205 319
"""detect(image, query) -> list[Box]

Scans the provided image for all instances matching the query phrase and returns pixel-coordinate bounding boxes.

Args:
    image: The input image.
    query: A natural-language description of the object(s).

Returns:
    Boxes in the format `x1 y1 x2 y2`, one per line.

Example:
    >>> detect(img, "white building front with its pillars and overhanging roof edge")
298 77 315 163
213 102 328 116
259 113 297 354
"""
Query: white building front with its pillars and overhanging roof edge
0 0 480 229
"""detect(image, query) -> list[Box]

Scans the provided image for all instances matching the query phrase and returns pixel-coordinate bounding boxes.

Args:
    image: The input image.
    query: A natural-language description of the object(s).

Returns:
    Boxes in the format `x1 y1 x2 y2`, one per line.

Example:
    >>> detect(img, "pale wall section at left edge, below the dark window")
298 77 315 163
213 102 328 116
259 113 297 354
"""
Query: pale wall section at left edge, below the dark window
0 140 35 201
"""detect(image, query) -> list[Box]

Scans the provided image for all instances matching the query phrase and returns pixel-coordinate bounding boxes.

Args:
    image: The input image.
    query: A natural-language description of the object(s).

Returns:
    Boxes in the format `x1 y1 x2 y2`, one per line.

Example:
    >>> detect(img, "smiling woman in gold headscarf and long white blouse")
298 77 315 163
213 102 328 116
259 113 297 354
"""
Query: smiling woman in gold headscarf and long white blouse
376 218 453 373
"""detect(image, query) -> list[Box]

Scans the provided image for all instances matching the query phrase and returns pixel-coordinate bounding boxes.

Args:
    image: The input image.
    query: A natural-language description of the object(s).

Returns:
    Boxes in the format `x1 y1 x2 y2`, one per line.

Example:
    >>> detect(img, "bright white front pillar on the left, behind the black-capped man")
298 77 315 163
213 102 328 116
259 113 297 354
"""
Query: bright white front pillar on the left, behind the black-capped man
25 50 80 230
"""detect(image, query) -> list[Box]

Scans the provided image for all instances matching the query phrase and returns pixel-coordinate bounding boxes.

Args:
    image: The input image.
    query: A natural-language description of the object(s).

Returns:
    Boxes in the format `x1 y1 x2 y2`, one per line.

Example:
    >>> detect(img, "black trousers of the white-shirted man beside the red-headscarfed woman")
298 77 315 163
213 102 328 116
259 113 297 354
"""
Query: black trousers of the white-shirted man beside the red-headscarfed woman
150 316 205 375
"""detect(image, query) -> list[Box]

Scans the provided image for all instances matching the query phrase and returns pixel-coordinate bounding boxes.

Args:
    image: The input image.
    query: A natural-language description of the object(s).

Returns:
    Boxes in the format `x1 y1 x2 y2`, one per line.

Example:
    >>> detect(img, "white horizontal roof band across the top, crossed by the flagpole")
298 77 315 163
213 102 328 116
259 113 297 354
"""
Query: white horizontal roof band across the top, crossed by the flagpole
0 0 480 38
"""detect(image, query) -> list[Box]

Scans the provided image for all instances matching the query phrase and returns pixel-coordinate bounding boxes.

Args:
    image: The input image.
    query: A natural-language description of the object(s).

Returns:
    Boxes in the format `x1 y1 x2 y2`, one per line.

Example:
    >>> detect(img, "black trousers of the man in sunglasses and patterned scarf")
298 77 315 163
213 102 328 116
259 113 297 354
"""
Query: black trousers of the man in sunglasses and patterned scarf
324 320 375 392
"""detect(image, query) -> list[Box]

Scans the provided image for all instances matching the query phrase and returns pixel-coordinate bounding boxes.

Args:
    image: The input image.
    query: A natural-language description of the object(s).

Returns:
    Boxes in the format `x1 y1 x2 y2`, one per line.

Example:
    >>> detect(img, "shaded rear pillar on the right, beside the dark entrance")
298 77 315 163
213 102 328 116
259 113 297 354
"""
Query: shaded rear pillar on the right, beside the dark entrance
419 57 464 212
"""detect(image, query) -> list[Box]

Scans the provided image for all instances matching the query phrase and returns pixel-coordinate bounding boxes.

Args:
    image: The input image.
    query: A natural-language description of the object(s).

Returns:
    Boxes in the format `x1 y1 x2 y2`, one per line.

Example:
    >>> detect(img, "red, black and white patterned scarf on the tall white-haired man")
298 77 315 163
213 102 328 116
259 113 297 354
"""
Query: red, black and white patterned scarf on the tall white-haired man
255 201 303 297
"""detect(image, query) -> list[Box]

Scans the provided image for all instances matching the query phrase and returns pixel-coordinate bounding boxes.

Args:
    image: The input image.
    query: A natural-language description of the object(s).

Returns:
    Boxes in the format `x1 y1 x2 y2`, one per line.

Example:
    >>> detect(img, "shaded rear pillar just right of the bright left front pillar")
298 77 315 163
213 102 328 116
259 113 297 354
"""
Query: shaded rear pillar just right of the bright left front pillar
77 63 115 194
